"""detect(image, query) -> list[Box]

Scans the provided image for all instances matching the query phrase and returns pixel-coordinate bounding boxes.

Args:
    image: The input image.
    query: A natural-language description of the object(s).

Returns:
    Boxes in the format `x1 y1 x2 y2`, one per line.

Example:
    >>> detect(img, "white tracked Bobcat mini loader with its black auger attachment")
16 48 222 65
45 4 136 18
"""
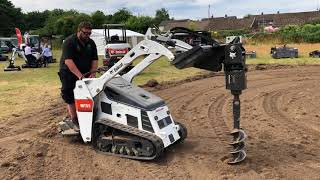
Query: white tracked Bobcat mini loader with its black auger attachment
59 27 246 164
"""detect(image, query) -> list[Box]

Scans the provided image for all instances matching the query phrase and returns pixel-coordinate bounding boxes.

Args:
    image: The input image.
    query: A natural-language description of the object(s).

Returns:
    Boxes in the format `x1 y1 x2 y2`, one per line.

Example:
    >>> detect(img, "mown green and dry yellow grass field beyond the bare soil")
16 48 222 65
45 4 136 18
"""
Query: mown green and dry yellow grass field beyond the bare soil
0 44 320 117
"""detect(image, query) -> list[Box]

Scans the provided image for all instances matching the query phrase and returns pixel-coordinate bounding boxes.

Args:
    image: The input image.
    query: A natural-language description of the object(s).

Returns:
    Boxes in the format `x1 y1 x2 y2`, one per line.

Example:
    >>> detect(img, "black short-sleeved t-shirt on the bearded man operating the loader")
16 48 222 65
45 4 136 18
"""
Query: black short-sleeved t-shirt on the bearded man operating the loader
60 34 98 74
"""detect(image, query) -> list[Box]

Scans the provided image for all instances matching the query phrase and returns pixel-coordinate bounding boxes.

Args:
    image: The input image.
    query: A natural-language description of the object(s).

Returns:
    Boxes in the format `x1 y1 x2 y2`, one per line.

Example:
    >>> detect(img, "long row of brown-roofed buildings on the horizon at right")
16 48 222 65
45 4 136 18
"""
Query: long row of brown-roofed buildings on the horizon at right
159 11 320 31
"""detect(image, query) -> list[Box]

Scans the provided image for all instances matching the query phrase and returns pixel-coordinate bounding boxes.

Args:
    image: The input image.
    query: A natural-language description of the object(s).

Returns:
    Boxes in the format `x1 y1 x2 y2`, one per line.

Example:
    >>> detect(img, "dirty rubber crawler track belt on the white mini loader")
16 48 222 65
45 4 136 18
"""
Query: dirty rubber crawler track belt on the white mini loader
93 119 164 160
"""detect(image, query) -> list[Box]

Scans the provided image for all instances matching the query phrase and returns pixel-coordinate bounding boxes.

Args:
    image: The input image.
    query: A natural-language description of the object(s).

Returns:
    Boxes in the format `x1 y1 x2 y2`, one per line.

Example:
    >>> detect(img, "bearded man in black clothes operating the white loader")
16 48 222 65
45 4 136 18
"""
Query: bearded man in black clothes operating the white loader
58 22 98 131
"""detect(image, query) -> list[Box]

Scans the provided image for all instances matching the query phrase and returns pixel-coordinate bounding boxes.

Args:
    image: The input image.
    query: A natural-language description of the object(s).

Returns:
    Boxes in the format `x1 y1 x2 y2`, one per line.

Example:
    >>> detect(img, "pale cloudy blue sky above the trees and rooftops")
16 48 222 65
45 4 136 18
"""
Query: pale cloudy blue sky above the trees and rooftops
11 0 320 20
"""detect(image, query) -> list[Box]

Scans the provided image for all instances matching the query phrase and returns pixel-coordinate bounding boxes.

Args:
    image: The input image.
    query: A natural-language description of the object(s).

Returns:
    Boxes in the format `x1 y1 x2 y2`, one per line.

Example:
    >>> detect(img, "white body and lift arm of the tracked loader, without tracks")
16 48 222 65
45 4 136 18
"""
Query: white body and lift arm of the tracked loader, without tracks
74 39 180 147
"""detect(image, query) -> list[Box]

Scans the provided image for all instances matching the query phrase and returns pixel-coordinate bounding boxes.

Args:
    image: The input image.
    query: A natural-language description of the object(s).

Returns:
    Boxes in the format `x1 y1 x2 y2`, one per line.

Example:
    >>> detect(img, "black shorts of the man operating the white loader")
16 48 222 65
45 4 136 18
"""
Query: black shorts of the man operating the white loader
58 71 78 104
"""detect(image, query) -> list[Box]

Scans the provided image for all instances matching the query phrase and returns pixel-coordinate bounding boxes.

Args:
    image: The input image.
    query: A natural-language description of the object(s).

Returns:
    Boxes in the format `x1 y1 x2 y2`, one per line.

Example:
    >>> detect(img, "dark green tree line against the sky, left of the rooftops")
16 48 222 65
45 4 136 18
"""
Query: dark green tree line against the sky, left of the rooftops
0 0 170 37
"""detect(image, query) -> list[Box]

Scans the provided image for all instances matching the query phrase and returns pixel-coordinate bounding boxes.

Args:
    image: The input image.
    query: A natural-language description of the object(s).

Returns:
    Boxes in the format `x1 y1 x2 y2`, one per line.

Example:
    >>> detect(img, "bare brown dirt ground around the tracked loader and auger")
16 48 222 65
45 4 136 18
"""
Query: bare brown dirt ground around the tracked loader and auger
0 65 320 180
